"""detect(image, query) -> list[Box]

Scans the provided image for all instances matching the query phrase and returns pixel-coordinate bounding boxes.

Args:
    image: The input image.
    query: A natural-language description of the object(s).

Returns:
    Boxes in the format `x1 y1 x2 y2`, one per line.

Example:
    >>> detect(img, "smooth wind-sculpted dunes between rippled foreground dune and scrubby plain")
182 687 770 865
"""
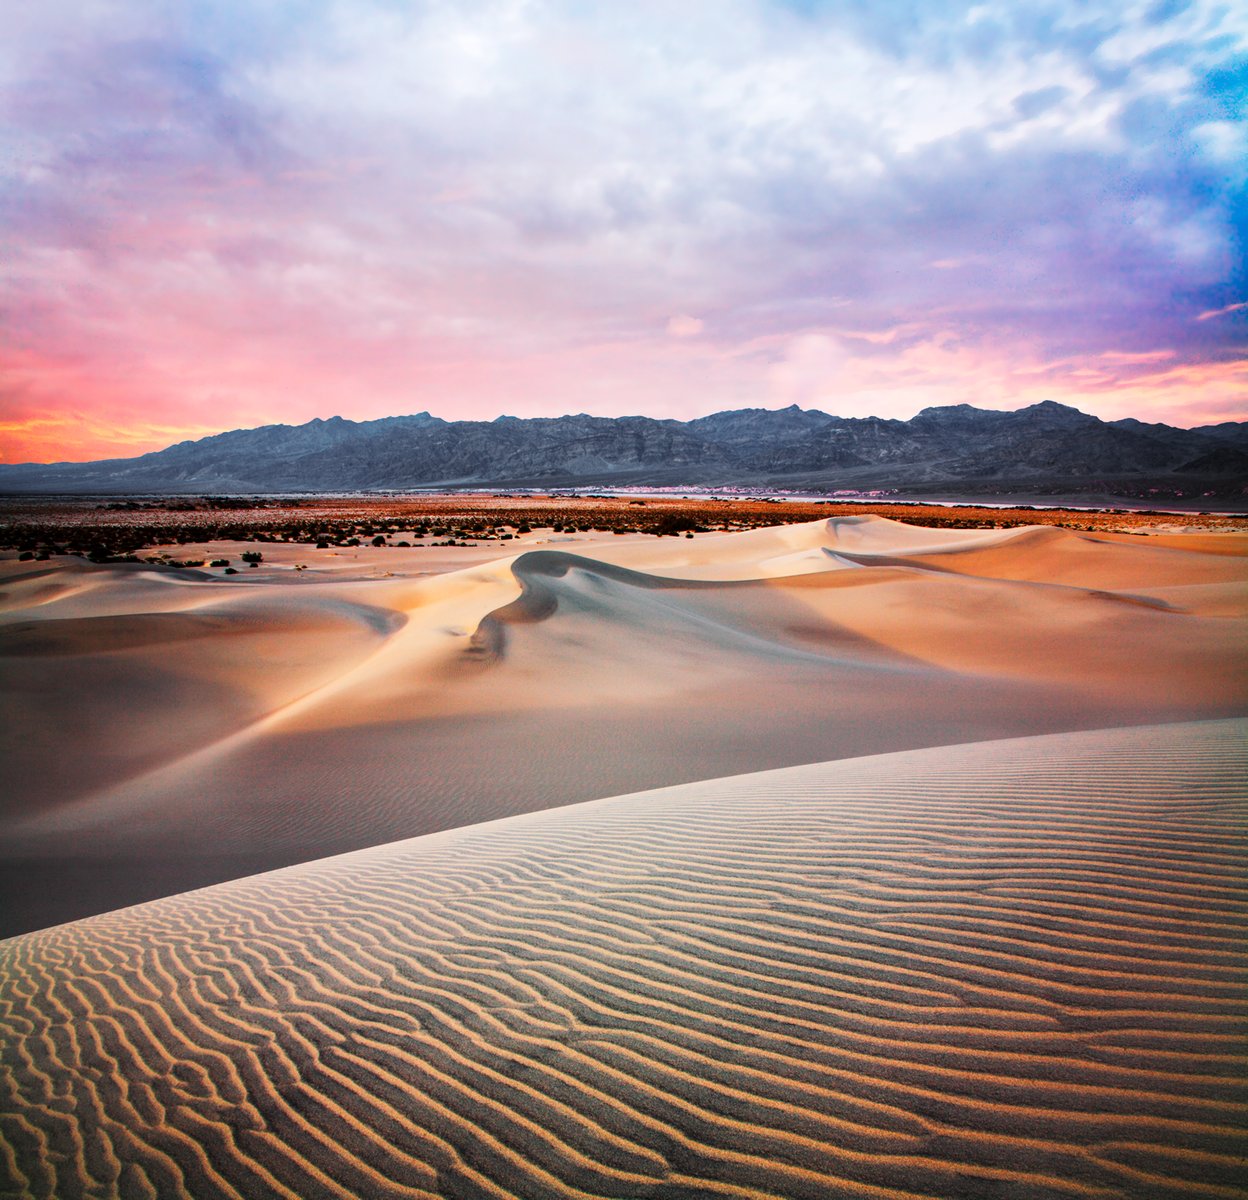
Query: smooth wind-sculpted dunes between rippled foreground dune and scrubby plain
0 516 1248 934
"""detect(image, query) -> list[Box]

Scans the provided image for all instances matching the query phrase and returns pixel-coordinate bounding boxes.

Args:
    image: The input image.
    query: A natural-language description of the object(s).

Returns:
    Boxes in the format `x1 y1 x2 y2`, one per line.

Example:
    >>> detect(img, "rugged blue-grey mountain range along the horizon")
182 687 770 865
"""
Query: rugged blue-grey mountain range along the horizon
0 400 1248 496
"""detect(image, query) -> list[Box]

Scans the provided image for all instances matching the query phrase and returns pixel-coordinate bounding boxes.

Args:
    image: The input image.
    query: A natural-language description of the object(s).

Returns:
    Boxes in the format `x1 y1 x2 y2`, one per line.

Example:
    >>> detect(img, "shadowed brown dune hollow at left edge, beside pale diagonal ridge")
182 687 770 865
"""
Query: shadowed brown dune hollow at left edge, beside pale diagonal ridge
0 581 406 820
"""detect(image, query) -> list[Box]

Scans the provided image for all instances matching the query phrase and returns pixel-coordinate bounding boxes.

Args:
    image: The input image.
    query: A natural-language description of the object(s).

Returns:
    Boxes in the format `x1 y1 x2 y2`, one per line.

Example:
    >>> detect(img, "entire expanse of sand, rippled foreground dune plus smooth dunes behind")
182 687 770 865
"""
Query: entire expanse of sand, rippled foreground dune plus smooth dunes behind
0 515 1248 1200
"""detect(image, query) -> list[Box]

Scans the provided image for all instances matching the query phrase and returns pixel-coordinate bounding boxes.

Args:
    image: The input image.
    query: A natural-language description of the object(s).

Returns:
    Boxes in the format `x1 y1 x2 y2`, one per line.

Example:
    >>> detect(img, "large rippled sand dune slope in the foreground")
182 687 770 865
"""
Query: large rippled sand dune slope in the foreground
0 721 1248 1200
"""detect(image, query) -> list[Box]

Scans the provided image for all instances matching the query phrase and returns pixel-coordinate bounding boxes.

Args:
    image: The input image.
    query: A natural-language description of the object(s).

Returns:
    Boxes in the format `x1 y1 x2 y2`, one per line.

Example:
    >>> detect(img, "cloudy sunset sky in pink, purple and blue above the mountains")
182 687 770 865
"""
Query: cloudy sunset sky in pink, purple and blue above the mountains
0 0 1248 462
